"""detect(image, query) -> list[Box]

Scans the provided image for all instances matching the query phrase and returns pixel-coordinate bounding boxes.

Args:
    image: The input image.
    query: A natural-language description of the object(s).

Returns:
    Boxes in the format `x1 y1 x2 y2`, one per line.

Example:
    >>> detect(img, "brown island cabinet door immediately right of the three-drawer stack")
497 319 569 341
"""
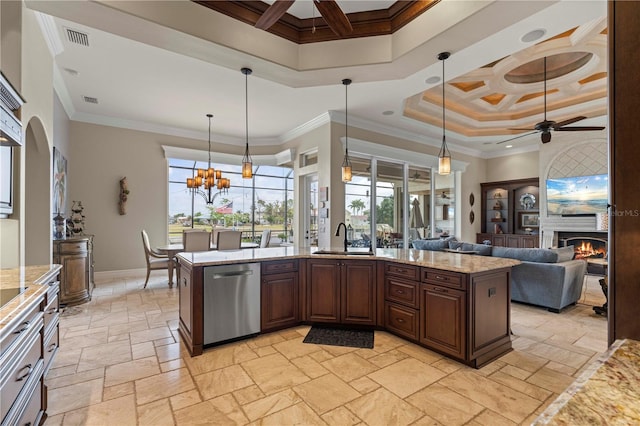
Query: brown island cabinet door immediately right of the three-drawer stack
420 284 466 360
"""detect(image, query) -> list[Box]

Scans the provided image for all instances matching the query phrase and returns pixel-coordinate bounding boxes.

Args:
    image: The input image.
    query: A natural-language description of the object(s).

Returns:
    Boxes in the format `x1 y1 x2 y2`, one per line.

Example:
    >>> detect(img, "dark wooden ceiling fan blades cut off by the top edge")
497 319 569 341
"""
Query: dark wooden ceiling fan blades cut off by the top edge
255 0 353 37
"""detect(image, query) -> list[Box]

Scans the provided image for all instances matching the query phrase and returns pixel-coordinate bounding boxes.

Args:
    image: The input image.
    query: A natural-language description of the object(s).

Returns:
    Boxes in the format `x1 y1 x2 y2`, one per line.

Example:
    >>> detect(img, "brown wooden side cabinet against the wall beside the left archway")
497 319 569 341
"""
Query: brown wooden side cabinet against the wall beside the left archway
53 235 94 305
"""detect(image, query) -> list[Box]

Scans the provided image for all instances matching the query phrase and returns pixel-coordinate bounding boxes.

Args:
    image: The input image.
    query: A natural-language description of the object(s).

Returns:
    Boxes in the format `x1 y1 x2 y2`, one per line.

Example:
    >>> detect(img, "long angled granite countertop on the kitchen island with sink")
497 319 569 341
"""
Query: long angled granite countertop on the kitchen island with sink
178 247 520 274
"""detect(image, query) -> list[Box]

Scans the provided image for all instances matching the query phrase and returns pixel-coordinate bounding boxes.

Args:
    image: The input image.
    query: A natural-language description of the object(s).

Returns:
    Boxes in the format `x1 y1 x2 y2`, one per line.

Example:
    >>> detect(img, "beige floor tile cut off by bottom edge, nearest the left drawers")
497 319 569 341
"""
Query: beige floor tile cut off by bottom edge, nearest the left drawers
64 395 136 426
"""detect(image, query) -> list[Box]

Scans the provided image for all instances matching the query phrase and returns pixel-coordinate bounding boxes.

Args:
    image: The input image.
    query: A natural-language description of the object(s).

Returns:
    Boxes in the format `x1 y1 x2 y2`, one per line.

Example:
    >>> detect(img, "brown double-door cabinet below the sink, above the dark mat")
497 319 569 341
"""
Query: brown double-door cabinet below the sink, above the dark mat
306 259 377 325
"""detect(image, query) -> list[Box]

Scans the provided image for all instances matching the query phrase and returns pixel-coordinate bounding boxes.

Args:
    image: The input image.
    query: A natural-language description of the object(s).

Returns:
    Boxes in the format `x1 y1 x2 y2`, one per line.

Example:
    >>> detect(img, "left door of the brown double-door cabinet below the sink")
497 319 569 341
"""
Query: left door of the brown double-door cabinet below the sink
307 260 341 322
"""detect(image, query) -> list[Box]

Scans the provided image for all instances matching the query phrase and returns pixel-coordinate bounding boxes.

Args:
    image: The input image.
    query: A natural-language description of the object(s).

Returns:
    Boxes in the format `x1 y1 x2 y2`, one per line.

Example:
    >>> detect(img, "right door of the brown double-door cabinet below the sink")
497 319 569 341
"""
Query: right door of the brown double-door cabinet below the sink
340 260 376 325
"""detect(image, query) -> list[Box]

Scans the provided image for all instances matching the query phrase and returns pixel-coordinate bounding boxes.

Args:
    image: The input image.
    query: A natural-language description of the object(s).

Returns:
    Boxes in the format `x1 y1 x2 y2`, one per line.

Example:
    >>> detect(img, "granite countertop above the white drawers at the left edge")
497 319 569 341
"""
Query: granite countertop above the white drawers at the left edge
0 264 62 330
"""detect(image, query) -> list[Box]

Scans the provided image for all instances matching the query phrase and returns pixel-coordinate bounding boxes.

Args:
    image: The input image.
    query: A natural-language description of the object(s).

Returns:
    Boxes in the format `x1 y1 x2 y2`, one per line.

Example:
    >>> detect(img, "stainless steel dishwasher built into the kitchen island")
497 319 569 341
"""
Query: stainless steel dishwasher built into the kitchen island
203 263 260 345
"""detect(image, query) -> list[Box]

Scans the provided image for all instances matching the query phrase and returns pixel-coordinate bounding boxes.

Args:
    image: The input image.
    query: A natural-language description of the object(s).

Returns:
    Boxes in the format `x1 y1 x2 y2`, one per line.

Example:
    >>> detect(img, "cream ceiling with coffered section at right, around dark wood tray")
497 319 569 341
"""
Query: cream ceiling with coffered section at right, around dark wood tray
25 0 607 157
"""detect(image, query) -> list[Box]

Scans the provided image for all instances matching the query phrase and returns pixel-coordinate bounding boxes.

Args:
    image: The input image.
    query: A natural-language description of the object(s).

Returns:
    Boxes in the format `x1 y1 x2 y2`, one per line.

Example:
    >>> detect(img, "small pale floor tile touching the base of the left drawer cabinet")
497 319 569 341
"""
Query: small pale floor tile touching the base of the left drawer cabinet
47 378 104 416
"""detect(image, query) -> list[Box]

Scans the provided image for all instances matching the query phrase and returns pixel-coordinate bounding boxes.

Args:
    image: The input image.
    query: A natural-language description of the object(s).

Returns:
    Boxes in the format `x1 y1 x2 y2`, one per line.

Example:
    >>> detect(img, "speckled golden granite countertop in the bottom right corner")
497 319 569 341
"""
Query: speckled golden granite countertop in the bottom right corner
533 339 640 425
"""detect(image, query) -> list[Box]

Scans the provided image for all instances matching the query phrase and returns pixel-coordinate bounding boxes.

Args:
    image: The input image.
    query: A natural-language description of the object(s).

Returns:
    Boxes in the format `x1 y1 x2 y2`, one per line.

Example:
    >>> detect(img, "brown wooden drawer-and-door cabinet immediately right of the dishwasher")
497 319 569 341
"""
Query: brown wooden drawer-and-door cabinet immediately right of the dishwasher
260 260 300 333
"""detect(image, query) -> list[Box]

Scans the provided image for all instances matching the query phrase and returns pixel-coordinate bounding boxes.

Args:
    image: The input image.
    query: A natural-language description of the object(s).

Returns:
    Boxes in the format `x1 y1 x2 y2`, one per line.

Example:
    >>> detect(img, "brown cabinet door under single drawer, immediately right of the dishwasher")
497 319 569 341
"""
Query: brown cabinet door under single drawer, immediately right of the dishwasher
260 272 299 332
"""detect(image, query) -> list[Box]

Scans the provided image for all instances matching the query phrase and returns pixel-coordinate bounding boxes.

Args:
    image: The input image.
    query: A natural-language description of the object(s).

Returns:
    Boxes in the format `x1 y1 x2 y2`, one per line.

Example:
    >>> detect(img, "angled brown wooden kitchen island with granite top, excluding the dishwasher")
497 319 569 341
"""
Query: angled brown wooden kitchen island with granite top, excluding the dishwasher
177 247 520 368
